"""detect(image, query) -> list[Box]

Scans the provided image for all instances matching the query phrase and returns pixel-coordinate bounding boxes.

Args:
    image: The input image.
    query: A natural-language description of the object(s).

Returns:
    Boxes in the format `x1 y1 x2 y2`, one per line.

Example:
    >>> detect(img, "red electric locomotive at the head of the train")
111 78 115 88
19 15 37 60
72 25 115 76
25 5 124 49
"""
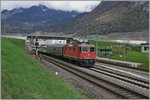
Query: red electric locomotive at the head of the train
63 43 96 67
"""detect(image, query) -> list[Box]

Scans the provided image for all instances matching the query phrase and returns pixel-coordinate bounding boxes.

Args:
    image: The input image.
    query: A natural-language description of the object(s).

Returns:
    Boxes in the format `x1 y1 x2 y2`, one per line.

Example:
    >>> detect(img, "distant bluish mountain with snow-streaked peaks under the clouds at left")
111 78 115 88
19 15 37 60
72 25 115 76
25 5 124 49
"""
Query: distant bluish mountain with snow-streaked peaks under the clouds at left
1 5 80 33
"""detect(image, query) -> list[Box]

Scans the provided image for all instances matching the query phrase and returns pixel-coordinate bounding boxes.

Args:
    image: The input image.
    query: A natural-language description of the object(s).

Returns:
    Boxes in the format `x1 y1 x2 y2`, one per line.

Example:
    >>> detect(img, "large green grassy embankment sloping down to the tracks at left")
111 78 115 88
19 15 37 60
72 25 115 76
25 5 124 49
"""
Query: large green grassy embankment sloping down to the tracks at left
1 38 87 99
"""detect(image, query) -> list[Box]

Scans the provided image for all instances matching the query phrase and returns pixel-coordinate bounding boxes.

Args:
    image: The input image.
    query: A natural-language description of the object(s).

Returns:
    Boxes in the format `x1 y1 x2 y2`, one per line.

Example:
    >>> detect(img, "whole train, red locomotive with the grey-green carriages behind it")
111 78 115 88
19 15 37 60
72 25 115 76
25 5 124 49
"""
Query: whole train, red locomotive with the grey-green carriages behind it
38 42 96 67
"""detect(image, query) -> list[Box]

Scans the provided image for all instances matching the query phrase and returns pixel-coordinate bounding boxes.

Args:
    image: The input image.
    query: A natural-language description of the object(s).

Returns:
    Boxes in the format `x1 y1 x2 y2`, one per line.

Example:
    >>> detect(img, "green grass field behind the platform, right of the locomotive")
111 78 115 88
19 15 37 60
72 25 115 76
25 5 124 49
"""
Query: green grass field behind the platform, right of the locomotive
89 40 149 70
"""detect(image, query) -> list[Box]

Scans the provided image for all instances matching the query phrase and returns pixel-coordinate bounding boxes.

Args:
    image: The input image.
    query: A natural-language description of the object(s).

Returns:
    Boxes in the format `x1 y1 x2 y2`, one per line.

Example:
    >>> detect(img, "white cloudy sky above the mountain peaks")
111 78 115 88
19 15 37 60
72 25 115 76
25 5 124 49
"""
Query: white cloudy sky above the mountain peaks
1 0 100 12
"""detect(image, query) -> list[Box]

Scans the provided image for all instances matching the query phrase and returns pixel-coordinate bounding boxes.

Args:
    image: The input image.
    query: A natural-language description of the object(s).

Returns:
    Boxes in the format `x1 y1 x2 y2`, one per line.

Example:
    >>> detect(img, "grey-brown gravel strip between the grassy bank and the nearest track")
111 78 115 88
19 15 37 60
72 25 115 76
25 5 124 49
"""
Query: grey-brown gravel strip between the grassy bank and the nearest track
41 59 124 99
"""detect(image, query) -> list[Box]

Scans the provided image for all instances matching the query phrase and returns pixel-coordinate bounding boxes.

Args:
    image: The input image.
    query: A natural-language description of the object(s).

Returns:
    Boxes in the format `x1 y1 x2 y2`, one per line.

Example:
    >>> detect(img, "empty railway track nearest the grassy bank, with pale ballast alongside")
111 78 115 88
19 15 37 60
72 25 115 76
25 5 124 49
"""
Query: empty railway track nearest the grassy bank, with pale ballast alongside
41 54 149 99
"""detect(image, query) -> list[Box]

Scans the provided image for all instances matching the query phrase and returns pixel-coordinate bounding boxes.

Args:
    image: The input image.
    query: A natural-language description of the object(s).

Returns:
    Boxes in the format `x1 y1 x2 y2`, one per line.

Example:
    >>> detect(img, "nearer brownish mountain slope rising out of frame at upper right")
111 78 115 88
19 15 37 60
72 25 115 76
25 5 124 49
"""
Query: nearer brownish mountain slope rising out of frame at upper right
53 1 149 34
